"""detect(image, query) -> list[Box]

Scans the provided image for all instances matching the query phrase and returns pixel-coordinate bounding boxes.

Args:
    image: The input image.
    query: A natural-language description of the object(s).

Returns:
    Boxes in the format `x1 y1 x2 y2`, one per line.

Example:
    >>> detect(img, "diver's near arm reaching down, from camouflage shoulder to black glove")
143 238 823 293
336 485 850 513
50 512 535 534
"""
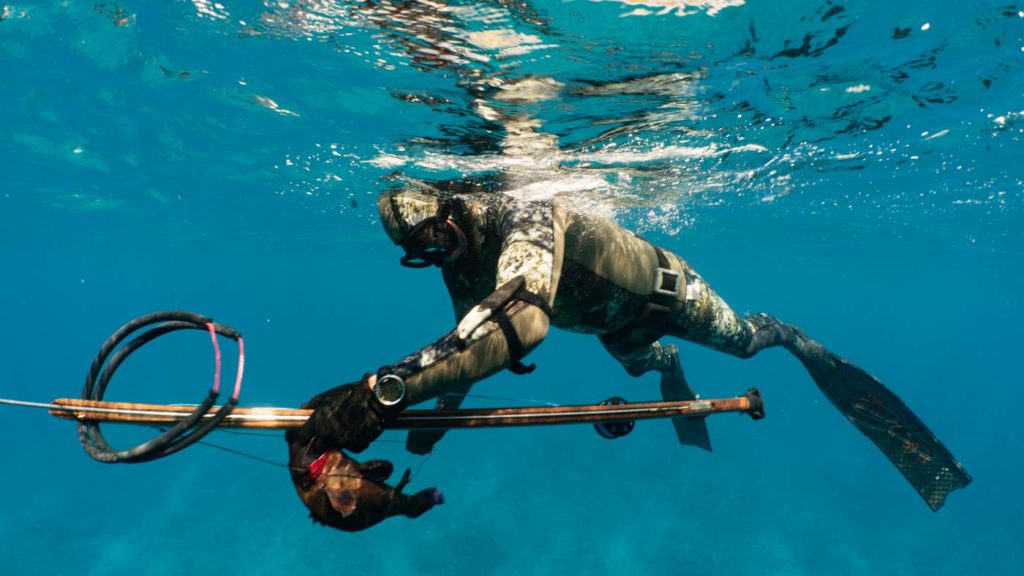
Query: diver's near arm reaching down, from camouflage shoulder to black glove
289 202 563 452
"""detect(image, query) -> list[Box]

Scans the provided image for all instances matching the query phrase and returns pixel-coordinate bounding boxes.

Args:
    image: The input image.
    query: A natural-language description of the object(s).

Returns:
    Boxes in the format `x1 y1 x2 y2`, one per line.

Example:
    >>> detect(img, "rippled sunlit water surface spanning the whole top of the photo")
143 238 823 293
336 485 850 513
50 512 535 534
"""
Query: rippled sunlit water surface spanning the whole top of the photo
0 0 1024 238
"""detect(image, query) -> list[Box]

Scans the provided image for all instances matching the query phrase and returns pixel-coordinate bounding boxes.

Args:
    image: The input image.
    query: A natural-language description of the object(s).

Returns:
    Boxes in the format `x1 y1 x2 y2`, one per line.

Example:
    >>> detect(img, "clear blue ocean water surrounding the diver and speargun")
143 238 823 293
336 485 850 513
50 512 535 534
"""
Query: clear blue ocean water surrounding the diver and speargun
0 0 1024 576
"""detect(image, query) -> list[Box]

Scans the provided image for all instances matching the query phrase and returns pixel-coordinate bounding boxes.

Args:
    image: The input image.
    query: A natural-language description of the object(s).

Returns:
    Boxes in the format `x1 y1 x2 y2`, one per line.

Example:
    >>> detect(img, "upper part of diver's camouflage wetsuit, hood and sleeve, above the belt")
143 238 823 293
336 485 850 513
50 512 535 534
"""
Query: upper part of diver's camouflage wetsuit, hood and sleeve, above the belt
378 191 685 404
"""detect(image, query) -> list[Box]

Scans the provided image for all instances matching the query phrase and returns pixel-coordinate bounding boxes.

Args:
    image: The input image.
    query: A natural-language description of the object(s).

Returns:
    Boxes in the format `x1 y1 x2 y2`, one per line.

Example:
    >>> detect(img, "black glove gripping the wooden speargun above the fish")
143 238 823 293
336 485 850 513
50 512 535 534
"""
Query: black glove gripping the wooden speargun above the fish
285 374 401 452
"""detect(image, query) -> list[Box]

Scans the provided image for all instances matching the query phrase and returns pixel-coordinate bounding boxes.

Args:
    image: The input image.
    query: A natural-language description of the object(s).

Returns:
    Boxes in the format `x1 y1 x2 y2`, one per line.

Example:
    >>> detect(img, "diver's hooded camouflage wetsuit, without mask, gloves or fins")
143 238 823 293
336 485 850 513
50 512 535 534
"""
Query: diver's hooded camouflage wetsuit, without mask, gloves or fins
378 191 791 408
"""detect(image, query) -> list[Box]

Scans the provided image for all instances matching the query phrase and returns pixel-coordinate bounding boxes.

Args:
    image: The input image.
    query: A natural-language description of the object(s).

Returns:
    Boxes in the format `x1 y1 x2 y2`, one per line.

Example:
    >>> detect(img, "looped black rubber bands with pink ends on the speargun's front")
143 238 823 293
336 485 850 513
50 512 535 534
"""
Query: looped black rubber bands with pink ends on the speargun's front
78 311 245 463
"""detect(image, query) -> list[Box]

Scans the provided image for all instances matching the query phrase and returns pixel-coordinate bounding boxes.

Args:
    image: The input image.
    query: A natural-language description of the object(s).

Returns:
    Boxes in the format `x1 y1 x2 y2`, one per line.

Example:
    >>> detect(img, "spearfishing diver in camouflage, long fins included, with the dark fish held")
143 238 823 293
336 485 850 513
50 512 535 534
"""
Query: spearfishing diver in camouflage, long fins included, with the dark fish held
286 183 971 522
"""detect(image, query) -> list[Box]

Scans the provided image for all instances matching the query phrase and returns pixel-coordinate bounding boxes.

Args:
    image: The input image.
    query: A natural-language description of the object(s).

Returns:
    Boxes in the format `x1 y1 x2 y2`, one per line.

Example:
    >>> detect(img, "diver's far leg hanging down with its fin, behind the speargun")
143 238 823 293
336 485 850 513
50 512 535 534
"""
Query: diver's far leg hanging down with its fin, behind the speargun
601 338 711 452
